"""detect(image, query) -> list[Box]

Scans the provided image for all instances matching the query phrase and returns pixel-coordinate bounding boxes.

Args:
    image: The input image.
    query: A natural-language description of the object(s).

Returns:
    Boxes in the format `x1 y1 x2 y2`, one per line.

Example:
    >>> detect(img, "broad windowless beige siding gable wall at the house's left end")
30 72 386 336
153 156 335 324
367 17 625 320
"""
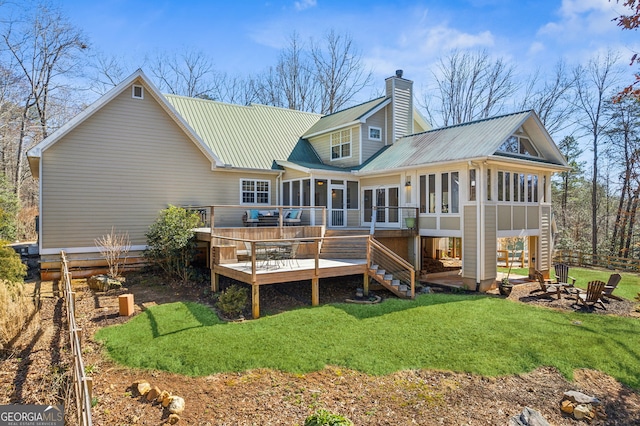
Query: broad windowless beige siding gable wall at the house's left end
41 88 272 249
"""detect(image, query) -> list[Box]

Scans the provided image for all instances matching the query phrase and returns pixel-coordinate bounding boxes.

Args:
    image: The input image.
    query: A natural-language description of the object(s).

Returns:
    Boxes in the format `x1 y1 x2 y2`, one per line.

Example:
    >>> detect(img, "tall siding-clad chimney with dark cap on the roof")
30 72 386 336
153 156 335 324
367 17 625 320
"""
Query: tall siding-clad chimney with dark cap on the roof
385 70 413 142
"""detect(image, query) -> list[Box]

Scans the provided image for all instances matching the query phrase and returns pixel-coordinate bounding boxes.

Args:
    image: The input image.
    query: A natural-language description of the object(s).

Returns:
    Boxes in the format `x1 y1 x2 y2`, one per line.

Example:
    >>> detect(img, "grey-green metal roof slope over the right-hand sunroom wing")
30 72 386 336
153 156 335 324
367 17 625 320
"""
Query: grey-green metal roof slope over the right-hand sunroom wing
360 111 566 173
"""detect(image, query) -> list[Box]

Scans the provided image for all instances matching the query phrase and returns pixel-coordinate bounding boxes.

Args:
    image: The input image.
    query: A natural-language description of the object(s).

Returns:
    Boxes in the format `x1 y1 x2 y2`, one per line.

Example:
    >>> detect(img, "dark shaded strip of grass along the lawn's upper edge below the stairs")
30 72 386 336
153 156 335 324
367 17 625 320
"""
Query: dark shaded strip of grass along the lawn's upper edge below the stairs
331 294 489 319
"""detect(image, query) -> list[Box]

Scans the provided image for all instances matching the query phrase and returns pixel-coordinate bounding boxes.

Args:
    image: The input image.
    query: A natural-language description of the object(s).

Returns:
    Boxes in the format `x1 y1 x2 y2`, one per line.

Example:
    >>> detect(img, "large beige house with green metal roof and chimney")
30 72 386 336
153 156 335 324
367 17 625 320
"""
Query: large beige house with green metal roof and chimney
28 70 567 291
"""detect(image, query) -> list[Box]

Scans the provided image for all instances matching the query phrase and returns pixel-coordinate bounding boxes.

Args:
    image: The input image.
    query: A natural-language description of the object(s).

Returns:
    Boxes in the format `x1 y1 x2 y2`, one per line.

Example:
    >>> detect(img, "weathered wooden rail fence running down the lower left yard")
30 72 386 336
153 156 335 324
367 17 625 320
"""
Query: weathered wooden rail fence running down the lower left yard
60 252 93 426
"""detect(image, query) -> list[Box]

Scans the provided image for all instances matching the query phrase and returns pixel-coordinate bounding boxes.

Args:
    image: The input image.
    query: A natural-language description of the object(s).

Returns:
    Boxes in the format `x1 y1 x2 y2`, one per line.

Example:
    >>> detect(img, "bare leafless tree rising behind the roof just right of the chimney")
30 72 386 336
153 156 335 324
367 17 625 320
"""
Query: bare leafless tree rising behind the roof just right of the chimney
423 50 517 126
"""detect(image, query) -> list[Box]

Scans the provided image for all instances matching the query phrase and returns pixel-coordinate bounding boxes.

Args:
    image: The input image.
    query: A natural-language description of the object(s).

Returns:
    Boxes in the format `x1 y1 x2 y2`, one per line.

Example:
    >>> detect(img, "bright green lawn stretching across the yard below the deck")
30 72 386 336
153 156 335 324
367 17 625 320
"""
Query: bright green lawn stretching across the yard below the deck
96 294 640 388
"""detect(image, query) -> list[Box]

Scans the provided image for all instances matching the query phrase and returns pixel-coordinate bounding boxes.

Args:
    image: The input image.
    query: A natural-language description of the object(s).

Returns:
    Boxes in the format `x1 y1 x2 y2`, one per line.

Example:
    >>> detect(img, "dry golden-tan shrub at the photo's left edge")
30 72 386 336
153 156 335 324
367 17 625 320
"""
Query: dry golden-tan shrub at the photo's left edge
0 280 39 349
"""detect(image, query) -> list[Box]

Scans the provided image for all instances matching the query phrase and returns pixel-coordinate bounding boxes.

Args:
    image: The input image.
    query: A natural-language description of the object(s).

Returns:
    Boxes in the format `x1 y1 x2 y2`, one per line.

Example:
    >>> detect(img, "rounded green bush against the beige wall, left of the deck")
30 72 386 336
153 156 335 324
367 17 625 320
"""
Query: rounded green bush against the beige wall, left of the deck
144 206 200 283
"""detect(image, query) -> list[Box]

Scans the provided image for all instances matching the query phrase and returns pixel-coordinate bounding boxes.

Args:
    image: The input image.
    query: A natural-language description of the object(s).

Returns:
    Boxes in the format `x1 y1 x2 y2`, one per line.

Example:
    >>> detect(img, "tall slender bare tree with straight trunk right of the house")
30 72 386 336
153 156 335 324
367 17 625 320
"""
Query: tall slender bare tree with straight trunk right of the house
574 51 619 256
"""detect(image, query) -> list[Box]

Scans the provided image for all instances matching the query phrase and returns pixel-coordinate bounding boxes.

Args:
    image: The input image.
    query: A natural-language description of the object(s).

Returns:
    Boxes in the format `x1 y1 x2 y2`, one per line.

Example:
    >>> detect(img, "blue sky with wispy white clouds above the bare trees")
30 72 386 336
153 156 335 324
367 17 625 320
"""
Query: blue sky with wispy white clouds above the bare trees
60 0 638 101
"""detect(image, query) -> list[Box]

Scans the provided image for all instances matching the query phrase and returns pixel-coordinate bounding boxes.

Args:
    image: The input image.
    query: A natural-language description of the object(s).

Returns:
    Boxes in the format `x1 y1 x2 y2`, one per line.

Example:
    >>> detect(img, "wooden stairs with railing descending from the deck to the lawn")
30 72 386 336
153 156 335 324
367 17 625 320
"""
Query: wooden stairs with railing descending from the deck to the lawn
367 238 415 299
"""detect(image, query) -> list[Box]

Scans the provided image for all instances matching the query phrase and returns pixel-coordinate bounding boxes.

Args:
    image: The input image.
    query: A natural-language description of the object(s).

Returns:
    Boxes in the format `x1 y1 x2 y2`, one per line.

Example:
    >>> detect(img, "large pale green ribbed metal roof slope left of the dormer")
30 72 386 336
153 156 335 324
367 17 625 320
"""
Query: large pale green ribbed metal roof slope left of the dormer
164 95 321 169
